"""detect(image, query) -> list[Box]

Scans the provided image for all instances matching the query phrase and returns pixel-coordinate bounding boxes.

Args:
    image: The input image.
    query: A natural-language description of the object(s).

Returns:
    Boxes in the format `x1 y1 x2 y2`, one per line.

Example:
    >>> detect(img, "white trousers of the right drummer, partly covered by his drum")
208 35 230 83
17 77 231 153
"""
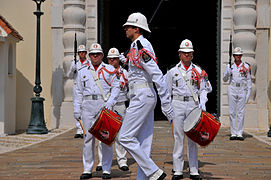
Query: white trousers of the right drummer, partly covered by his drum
172 99 198 175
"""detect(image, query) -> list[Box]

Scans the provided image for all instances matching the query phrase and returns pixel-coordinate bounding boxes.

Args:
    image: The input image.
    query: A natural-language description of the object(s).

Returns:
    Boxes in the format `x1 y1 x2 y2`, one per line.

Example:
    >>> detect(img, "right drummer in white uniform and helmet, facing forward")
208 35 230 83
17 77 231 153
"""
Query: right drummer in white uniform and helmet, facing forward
165 39 208 180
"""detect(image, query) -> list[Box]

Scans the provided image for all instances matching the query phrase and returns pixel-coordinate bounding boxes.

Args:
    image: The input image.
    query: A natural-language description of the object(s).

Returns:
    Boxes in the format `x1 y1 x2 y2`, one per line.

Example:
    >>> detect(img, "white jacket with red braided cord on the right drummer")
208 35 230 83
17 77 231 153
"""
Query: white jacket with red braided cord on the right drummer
165 62 209 104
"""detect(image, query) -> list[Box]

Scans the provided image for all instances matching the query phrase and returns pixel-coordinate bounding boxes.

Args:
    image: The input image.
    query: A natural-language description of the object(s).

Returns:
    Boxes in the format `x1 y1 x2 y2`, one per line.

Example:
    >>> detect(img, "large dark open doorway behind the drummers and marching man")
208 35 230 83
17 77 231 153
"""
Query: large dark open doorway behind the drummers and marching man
99 0 219 120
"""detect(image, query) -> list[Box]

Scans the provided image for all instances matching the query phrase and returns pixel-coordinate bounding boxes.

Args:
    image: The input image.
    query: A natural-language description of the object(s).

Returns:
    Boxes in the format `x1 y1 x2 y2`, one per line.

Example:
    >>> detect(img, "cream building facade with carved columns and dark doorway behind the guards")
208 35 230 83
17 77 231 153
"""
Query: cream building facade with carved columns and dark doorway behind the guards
0 0 271 134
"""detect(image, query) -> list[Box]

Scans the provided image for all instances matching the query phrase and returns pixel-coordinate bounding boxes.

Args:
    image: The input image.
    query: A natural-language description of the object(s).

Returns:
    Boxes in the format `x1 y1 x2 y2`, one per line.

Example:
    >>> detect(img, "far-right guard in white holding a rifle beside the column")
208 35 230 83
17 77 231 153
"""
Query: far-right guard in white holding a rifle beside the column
223 47 252 141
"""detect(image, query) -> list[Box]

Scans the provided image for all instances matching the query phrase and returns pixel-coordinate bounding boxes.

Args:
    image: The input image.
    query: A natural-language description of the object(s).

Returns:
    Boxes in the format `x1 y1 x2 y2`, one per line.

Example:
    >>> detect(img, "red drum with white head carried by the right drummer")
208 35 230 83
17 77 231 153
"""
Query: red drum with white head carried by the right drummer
184 108 221 146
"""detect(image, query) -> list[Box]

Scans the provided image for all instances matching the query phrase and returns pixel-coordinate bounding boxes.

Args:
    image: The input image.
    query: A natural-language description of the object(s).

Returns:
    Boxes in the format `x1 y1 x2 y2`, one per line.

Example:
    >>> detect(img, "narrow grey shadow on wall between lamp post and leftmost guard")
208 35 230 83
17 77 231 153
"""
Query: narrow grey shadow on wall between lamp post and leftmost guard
51 67 64 128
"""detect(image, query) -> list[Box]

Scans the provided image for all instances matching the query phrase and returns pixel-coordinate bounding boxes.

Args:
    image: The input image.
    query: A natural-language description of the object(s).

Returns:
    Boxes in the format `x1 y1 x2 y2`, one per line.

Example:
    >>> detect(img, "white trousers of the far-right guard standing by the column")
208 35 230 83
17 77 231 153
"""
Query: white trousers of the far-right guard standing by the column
228 85 247 136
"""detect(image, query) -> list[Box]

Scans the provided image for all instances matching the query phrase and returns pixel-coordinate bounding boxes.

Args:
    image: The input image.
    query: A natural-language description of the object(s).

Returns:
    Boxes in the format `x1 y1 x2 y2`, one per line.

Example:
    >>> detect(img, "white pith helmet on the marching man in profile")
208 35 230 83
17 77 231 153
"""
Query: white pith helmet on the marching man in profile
123 12 151 33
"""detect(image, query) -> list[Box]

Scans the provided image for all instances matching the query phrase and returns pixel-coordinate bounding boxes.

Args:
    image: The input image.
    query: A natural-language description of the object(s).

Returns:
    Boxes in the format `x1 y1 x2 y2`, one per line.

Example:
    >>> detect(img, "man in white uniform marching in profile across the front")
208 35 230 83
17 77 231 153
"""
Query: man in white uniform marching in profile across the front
119 13 174 180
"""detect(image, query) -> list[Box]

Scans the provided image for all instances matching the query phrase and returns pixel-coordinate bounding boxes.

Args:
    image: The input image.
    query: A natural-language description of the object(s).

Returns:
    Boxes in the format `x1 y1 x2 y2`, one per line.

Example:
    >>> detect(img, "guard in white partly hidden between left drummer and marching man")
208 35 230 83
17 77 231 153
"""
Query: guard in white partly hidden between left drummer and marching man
96 48 129 171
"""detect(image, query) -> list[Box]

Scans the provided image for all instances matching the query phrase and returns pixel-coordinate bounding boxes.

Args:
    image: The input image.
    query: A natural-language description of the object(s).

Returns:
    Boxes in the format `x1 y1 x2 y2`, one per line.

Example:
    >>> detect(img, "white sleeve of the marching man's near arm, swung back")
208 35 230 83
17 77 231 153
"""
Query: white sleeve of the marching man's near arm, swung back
141 60 171 104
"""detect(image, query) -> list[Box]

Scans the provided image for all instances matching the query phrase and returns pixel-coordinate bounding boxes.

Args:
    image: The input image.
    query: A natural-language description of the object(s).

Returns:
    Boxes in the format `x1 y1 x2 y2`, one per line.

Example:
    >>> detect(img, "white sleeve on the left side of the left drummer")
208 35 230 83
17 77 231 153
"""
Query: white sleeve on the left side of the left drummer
73 73 83 119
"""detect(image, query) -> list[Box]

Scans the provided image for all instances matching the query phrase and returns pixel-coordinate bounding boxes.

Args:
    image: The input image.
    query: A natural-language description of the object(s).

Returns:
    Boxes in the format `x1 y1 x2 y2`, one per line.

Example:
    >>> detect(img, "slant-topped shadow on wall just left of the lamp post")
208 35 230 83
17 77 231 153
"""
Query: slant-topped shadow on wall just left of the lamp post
16 69 34 132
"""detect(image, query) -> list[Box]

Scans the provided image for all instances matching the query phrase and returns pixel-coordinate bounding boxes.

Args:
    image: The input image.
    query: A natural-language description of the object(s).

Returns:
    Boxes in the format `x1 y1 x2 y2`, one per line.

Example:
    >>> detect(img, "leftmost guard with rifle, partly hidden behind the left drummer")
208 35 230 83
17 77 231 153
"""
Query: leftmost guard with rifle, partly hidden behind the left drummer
67 45 89 138
